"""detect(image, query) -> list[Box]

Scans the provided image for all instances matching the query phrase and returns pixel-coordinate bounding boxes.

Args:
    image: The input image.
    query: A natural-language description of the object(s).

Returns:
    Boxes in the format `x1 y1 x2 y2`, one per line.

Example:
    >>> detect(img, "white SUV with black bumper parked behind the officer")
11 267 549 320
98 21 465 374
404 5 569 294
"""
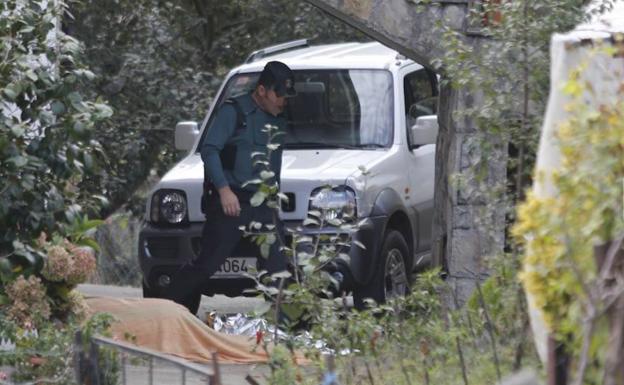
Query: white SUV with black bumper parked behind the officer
139 40 438 306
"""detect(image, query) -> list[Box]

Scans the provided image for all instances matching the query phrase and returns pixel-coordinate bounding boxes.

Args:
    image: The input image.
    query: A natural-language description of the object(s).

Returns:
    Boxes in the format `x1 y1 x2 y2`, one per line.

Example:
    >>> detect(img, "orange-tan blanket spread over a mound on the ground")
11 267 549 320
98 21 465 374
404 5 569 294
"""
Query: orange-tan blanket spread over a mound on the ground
86 297 268 363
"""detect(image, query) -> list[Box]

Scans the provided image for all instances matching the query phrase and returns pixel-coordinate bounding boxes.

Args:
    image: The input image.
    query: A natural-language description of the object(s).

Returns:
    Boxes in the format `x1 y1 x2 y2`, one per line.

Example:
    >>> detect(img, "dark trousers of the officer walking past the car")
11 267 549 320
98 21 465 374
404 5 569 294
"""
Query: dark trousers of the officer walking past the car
169 194 288 313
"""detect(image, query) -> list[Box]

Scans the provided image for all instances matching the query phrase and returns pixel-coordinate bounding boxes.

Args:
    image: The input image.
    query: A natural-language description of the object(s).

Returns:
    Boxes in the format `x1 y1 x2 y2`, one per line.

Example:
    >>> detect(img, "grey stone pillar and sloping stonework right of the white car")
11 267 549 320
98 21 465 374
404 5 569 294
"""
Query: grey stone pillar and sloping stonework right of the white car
306 0 507 304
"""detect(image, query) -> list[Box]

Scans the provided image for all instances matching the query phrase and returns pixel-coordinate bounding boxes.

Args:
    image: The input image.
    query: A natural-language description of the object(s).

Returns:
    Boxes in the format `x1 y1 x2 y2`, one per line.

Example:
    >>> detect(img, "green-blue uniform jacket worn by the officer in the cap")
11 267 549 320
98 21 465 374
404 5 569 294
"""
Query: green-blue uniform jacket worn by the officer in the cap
200 94 286 191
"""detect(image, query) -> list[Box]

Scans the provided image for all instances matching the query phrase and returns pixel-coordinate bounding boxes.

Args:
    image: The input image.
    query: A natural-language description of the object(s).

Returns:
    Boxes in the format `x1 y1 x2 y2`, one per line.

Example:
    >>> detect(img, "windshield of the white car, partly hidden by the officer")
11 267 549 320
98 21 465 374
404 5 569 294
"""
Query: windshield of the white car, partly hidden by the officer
201 69 394 149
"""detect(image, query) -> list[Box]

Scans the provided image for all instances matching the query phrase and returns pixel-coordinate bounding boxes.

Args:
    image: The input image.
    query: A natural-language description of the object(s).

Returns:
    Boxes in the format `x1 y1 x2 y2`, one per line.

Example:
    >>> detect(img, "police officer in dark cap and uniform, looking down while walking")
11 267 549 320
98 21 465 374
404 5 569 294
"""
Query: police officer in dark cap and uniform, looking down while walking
170 61 296 314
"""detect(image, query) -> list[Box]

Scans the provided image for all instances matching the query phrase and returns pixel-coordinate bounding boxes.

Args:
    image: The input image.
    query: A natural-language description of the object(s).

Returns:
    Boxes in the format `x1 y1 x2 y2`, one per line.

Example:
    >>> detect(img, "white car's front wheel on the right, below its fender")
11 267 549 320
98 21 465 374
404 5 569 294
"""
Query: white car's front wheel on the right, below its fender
353 230 409 310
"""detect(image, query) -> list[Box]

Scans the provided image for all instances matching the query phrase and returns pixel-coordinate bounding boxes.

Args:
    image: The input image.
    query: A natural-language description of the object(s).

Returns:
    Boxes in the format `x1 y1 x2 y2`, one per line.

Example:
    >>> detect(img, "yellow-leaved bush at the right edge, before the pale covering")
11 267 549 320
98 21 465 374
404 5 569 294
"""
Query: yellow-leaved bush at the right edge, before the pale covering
514 43 624 384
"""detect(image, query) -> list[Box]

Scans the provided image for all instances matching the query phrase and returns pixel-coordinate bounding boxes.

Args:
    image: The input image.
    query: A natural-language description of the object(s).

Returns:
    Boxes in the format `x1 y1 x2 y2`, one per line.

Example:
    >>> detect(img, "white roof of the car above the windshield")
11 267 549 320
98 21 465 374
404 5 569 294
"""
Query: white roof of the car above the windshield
233 42 414 72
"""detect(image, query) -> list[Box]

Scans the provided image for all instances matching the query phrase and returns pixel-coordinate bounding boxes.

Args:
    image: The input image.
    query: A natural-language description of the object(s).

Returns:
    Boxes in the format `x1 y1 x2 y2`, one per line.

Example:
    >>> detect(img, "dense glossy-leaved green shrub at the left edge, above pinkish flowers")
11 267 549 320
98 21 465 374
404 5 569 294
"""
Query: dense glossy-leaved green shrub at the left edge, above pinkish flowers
0 1 112 266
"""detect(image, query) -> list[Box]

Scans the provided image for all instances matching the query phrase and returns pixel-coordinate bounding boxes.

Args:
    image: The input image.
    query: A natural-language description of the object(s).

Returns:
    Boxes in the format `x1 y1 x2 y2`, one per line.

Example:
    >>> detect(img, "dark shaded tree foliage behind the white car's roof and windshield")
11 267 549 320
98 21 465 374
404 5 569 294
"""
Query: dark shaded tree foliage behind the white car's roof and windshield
65 0 362 217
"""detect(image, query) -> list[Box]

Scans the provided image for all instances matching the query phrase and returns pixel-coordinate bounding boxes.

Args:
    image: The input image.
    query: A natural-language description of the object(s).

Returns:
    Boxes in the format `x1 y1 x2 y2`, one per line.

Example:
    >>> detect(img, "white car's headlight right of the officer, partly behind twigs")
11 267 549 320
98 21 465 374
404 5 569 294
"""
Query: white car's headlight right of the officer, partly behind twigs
309 186 357 222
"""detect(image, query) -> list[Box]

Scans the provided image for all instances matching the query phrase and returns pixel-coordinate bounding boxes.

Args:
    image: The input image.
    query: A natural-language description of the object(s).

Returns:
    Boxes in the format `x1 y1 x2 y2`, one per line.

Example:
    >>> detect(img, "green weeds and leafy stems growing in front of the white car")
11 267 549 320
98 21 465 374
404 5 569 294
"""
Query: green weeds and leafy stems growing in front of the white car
236 126 538 385
